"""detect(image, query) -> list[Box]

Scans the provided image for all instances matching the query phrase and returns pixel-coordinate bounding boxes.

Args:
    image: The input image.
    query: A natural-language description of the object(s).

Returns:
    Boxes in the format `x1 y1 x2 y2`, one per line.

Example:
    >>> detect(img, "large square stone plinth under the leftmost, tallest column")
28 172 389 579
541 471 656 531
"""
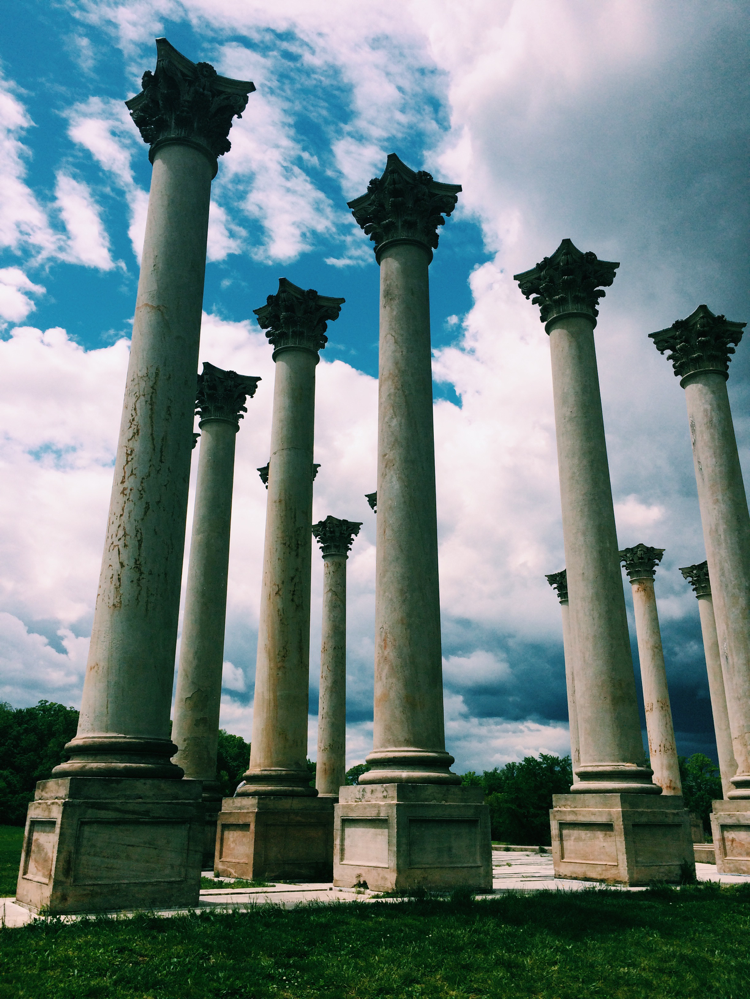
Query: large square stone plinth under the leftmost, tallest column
16 777 203 915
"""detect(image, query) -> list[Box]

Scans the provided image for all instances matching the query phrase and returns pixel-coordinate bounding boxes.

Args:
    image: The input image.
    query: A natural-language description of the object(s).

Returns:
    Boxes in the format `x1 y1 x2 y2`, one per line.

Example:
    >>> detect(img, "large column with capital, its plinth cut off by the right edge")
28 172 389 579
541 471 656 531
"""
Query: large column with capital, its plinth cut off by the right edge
650 305 750 874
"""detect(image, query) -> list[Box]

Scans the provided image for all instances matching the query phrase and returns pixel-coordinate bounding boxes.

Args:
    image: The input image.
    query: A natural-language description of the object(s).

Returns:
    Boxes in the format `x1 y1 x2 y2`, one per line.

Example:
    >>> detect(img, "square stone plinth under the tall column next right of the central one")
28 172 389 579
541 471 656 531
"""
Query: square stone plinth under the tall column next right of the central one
550 794 695 885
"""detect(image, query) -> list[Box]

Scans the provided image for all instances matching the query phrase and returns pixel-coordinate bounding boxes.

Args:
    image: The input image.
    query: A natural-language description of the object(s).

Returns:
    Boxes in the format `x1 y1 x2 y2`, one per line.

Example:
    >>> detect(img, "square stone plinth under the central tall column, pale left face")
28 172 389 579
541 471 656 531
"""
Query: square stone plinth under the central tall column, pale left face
333 784 492 891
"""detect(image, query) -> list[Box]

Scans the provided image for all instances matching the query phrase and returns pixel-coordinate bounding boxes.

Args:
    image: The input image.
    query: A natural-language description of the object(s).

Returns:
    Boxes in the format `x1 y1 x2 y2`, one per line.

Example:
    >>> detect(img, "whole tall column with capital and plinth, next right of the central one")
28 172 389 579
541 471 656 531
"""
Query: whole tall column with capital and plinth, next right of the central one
515 239 693 884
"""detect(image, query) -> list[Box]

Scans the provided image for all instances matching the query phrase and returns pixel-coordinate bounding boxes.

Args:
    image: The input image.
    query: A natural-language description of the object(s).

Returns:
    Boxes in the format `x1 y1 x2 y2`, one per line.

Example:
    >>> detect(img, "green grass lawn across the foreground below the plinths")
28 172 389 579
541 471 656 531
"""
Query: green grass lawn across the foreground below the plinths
0 885 750 999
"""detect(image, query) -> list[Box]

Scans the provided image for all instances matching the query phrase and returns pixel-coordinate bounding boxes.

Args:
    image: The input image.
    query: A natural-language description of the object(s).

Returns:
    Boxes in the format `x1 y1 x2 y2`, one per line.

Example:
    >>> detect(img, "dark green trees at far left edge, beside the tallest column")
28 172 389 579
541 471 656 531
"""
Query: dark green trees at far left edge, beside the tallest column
0 701 78 826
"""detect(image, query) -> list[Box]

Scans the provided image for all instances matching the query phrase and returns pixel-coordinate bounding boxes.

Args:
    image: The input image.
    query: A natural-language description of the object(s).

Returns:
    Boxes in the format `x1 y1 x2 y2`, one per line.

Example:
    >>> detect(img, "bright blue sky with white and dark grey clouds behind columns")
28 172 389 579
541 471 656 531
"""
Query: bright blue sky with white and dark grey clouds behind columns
0 0 750 769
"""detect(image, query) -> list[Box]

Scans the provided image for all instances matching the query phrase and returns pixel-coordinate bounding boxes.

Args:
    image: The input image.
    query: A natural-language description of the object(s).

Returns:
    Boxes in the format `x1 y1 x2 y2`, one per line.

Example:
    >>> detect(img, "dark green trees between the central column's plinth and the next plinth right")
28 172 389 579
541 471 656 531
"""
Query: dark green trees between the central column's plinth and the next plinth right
461 753 573 846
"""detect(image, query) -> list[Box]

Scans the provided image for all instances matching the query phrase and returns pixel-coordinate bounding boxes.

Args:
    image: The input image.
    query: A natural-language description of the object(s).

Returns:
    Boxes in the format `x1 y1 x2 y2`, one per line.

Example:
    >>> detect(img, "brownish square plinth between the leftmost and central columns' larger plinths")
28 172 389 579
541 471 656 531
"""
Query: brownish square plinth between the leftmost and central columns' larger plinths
214 794 333 882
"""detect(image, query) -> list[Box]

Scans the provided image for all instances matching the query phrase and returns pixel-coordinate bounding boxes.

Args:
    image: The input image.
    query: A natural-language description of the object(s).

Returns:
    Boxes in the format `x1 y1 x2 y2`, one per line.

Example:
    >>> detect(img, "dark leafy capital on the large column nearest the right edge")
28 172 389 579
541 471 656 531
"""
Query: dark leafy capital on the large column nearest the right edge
649 305 747 384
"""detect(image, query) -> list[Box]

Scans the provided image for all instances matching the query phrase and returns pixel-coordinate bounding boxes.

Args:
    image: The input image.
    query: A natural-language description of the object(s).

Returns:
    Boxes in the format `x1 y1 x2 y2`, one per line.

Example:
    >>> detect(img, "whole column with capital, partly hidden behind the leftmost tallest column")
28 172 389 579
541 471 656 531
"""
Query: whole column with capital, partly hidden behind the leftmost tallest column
172 362 260 867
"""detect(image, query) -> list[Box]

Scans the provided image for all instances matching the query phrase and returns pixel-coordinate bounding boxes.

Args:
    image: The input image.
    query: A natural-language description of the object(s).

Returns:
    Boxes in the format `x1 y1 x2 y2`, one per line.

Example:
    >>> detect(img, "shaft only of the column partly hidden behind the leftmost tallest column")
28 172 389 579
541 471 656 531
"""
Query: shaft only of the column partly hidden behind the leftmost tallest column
172 420 237 784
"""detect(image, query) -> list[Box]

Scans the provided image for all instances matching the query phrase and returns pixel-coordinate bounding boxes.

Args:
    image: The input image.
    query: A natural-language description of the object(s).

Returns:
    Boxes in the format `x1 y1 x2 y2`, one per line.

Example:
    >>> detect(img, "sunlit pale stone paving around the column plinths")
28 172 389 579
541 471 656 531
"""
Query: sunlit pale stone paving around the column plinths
0 850 750 927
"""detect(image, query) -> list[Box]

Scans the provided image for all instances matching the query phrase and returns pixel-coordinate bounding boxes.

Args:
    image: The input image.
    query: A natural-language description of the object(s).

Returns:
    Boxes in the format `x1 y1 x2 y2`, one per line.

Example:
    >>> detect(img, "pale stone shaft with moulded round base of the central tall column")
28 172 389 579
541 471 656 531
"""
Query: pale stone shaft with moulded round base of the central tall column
368 242 459 783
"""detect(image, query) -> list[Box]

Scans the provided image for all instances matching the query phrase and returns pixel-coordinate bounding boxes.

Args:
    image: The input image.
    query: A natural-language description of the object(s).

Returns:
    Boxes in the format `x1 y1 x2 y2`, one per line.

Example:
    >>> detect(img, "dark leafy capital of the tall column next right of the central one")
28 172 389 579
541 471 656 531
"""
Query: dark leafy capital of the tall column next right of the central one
513 239 620 332
